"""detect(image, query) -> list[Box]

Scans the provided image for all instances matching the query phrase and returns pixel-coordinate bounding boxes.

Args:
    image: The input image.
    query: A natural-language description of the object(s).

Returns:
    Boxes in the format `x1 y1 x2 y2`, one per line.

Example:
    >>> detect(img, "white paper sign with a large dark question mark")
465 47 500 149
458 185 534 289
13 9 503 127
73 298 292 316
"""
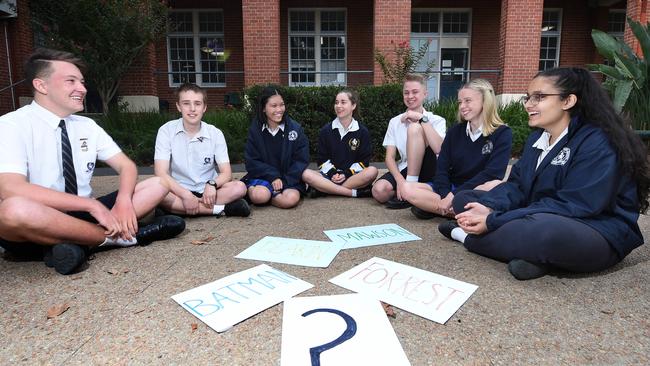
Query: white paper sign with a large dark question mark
281 294 410 366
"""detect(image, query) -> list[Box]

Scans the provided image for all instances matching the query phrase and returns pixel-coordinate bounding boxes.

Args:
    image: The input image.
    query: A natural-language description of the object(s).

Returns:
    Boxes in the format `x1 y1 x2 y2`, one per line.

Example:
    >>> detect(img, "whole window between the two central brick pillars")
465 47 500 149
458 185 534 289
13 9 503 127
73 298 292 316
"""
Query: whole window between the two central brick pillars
289 9 347 85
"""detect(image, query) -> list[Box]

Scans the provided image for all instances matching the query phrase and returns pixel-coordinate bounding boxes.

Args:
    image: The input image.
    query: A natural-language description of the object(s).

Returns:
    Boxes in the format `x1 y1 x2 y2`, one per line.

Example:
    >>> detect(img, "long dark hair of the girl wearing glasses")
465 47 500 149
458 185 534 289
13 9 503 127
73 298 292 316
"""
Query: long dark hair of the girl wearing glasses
535 67 650 213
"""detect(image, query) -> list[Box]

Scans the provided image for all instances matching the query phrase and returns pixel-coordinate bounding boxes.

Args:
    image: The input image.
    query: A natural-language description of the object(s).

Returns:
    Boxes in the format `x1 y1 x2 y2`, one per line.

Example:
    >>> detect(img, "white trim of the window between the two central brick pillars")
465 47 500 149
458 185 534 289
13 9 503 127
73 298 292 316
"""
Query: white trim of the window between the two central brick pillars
287 8 348 86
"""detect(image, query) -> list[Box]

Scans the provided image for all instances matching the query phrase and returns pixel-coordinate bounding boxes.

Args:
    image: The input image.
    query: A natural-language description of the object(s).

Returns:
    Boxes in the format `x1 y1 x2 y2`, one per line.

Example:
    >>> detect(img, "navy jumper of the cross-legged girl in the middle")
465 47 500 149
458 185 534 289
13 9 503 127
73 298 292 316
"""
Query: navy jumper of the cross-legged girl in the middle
317 117 372 179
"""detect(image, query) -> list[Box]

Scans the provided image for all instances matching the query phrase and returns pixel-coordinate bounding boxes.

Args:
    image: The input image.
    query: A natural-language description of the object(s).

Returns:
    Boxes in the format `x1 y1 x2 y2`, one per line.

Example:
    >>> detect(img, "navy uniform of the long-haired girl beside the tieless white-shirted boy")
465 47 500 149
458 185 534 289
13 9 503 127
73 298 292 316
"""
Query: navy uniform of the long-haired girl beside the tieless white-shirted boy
242 118 309 192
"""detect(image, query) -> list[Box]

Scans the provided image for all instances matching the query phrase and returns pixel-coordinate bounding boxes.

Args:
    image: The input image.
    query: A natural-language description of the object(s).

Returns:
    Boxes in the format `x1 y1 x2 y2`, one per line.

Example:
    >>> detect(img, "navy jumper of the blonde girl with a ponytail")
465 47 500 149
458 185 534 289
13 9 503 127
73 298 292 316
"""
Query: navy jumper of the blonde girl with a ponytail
433 122 512 198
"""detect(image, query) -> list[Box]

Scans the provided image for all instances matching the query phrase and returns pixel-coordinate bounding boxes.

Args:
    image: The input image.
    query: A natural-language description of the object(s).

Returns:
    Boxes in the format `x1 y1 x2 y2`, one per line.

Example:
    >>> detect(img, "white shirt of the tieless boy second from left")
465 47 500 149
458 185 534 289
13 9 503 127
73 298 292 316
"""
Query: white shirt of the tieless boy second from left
154 118 230 193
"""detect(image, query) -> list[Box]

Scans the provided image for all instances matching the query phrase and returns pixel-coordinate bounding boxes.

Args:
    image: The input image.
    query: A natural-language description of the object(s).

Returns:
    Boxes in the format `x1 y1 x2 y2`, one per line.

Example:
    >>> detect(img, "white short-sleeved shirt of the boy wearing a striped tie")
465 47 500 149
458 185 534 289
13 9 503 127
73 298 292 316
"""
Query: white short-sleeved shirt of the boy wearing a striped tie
0 102 122 197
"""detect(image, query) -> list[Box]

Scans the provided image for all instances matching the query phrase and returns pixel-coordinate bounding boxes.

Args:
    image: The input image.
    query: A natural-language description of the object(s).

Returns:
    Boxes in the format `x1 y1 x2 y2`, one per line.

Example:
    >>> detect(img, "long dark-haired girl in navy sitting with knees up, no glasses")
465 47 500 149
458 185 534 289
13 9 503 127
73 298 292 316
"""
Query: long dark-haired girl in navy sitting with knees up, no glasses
242 86 309 208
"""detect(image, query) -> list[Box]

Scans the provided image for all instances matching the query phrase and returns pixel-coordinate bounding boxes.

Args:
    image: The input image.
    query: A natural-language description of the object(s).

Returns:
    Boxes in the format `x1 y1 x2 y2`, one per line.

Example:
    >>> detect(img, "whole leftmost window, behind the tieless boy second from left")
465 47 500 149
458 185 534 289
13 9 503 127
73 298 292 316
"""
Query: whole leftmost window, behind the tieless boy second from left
167 10 226 86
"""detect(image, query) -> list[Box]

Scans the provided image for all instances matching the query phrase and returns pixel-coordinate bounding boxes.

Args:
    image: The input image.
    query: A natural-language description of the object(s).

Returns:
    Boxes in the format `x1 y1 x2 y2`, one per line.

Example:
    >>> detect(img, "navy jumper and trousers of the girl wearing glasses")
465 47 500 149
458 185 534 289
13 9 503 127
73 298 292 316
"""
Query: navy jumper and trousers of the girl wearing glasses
454 118 643 272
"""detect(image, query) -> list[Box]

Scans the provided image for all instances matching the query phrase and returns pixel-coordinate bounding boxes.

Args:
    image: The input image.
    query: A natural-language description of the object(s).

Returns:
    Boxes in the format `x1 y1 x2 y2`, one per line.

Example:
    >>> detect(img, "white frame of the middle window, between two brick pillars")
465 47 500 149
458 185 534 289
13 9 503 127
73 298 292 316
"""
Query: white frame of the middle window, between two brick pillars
287 7 348 86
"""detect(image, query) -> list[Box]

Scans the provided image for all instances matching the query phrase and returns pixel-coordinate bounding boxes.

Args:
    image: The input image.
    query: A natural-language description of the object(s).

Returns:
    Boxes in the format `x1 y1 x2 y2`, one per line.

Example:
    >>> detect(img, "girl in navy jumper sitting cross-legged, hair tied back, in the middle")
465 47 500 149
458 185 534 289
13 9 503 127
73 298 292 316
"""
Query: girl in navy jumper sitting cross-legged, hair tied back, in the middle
302 89 377 198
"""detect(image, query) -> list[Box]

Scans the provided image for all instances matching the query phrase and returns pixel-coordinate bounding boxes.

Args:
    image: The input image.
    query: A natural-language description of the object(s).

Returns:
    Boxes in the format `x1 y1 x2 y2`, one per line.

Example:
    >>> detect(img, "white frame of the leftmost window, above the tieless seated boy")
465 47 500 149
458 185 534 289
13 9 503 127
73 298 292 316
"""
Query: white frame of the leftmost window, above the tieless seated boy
166 8 227 88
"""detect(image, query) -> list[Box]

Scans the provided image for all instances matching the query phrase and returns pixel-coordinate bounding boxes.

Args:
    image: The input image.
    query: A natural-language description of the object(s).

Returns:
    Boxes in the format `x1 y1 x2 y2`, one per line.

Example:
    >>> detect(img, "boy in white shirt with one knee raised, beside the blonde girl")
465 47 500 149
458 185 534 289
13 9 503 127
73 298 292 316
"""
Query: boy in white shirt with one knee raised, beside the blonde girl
372 74 447 209
